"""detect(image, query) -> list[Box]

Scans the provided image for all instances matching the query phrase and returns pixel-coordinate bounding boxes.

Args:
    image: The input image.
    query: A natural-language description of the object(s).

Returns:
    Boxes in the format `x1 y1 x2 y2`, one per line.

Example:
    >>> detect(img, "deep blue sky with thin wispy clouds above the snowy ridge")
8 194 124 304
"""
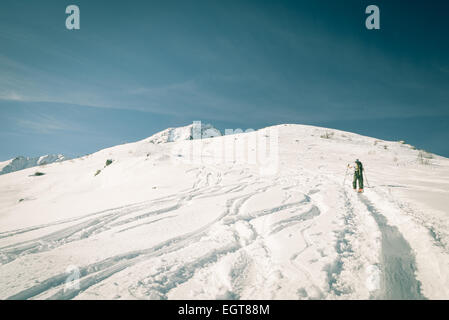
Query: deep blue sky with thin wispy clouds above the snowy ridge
0 0 449 160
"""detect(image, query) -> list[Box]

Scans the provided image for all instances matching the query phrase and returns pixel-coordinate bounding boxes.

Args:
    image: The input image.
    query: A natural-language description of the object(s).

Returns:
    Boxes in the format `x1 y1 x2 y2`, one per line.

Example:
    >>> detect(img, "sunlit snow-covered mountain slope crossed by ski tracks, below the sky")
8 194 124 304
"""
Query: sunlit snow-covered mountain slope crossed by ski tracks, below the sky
0 125 449 299
